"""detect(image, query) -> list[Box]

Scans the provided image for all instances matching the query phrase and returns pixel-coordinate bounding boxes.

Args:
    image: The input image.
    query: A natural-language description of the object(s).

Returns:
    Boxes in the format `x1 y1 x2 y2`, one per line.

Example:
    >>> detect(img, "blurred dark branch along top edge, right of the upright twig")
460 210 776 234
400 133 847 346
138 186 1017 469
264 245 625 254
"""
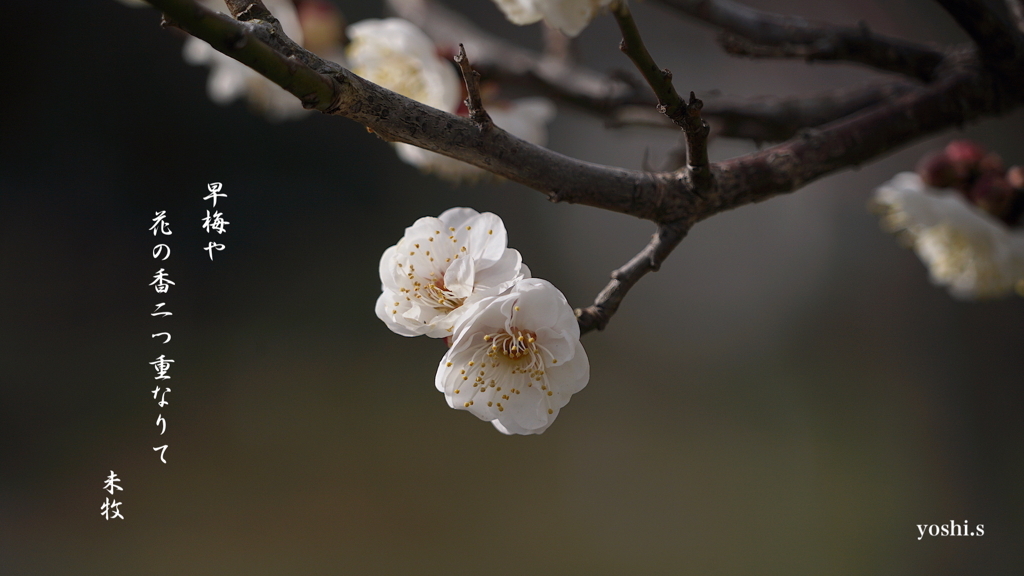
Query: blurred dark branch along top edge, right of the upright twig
660 0 952 82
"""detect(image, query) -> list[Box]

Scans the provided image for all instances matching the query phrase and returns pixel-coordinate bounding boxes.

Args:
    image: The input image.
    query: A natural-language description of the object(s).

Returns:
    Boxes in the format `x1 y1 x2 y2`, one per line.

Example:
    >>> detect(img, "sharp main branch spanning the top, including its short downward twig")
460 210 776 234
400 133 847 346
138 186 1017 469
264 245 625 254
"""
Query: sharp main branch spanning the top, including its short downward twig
140 0 1024 330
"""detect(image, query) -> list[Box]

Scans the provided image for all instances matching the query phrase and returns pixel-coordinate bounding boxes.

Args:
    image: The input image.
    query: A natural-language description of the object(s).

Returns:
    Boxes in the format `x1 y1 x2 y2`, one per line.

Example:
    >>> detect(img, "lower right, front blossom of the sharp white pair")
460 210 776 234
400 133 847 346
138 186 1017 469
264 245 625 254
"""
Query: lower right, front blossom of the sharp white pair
435 279 590 435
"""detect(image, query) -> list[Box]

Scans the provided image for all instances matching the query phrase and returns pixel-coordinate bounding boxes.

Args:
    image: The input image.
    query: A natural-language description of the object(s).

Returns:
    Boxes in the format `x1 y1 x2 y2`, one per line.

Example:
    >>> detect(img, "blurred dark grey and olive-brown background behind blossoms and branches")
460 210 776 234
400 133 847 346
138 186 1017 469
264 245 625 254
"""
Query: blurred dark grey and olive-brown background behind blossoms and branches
0 0 1024 575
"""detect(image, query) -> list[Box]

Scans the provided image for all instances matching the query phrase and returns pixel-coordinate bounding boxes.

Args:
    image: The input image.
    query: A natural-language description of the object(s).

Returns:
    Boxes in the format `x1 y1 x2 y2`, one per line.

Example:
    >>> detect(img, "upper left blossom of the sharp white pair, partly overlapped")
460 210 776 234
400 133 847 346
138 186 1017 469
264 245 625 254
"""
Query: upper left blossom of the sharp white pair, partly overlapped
377 208 529 338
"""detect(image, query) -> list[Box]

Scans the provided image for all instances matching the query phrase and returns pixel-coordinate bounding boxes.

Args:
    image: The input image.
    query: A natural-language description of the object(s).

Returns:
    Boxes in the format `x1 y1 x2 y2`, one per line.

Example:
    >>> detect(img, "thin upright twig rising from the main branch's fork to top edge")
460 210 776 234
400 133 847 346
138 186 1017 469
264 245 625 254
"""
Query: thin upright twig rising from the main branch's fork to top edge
611 0 711 183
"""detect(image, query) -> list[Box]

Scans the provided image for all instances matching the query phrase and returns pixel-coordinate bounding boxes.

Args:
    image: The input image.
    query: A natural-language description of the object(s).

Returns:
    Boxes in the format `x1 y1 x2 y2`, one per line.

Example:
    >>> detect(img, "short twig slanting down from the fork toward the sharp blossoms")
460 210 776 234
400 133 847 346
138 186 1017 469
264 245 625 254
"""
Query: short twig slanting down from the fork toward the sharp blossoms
575 222 690 333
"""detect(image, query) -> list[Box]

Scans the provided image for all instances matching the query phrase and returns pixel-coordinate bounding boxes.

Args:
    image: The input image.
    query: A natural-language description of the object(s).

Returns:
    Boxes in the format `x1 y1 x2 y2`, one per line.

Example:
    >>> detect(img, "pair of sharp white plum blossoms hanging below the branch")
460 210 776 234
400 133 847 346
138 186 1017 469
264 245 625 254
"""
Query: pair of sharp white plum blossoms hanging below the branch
377 208 590 435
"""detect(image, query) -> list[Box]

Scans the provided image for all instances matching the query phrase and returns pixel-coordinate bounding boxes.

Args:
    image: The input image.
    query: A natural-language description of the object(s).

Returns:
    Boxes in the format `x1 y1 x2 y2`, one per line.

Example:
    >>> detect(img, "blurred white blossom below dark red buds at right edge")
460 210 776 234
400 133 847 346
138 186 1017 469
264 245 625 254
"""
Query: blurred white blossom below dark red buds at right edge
874 172 1024 299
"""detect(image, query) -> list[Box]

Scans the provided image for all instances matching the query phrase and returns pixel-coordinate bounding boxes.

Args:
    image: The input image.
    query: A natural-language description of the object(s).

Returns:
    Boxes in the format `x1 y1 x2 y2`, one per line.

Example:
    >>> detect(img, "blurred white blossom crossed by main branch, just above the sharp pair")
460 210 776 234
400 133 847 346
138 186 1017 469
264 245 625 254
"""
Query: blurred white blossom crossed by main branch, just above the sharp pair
395 96 555 181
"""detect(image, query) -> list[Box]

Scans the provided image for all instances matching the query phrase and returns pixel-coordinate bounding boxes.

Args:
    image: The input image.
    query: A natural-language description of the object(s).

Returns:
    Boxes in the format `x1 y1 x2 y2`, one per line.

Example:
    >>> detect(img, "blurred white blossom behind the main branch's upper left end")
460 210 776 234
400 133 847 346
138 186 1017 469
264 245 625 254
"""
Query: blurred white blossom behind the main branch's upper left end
183 0 344 121
